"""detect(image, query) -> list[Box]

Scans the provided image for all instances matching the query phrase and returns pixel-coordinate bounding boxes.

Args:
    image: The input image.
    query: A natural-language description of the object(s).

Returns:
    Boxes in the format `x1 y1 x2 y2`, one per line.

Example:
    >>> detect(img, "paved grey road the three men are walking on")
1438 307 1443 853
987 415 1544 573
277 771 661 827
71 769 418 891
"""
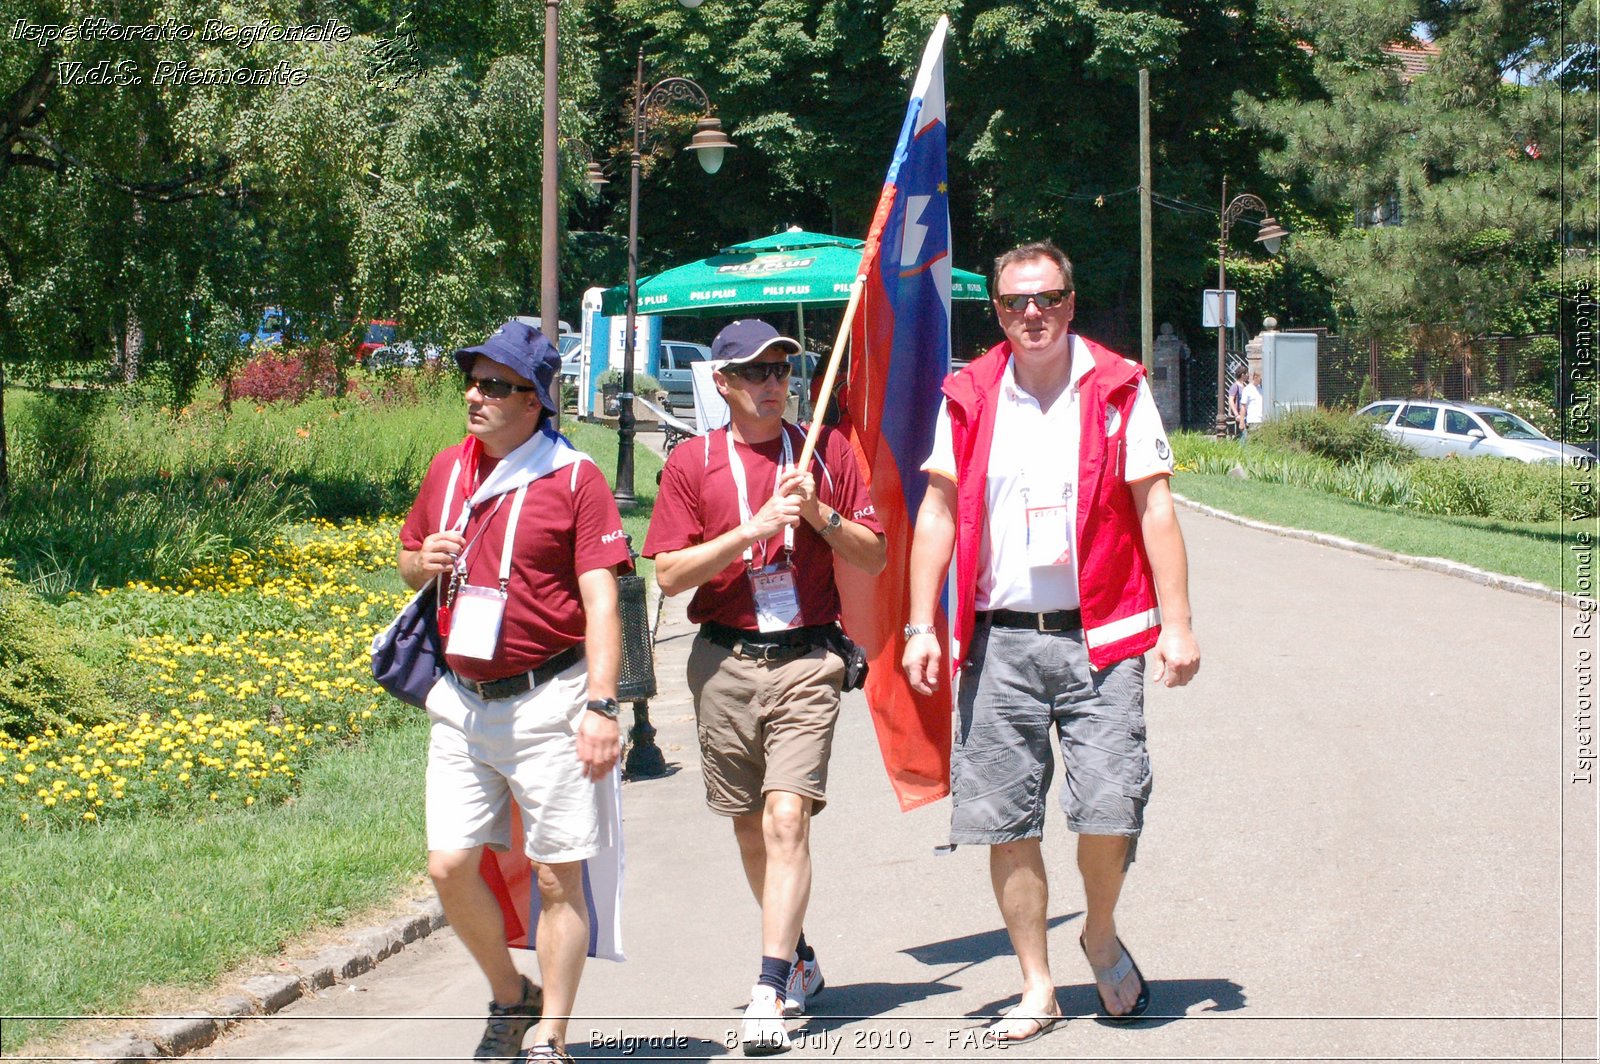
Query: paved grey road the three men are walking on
193 514 1595 1061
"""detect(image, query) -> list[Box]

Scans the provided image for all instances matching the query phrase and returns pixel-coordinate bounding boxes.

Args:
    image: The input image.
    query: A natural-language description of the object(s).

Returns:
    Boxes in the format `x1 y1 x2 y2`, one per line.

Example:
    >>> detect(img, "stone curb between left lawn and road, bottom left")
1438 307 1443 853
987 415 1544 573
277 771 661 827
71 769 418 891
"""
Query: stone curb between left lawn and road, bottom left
75 898 445 1064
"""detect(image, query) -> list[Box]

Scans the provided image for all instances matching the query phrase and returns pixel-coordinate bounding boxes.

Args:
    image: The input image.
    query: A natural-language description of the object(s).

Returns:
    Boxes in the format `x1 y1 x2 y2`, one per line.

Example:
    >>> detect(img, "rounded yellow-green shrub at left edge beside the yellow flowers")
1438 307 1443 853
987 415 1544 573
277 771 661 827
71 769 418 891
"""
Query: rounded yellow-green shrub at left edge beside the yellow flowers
0 558 112 739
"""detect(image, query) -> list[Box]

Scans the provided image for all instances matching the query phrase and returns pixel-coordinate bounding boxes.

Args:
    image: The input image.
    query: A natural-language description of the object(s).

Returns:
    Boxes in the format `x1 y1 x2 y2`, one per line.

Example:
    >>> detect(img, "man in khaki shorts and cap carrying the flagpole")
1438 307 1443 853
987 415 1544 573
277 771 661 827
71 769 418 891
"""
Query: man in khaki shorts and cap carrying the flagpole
645 318 885 1054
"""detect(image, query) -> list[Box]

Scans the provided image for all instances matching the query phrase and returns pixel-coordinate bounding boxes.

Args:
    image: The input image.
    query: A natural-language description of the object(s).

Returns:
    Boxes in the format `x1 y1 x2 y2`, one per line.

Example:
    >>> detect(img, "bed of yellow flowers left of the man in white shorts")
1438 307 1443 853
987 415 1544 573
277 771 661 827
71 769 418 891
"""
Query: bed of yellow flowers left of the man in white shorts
0 520 411 826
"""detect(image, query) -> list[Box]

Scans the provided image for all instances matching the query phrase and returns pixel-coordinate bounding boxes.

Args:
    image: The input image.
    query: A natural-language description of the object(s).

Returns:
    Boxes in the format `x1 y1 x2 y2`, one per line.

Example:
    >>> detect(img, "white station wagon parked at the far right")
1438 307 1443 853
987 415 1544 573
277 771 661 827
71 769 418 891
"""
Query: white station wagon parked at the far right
1355 398 1595 466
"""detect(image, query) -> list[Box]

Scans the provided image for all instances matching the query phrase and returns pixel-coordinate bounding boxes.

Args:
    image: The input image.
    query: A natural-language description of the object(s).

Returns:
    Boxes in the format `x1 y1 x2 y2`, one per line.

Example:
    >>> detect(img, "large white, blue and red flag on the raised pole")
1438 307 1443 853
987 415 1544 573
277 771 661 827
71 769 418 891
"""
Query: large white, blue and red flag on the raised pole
837 16 950 810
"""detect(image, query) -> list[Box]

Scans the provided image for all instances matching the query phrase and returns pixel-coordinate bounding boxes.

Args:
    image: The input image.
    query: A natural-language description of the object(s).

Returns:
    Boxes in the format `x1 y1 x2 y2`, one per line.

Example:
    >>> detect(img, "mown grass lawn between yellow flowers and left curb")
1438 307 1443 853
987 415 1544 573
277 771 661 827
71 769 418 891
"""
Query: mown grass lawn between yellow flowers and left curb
0 710 427 1054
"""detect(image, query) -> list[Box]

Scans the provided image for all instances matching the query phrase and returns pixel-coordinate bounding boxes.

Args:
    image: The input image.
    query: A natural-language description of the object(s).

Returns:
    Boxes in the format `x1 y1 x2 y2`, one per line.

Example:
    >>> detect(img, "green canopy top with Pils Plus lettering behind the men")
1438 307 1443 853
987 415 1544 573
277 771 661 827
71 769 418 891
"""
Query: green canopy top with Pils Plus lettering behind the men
600 229 989 317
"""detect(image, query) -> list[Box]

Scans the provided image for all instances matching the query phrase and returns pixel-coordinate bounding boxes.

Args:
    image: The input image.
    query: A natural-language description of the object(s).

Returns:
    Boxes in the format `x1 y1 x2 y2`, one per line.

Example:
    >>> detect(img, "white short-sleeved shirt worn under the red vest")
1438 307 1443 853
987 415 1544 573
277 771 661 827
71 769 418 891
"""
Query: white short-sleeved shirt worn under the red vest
922 334 1173 613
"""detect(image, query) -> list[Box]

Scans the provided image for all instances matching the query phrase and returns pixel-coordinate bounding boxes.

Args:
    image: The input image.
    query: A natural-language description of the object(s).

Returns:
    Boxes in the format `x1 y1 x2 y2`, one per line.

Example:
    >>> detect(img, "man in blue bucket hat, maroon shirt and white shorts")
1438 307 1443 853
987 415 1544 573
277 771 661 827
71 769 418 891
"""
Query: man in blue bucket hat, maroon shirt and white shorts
400 320 630 1062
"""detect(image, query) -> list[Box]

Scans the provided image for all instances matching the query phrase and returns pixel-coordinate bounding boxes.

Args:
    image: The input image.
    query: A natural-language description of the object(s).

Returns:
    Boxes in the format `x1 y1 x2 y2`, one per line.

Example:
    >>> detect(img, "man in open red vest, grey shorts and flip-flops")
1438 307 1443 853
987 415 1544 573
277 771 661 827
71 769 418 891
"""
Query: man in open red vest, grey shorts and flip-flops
902 242 1200 1045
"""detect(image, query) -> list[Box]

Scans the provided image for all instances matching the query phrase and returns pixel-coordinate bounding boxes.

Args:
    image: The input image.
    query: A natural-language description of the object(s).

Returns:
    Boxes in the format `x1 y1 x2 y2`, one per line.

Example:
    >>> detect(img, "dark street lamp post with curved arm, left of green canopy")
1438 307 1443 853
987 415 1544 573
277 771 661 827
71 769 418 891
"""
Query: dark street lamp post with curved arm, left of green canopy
611 48 733 510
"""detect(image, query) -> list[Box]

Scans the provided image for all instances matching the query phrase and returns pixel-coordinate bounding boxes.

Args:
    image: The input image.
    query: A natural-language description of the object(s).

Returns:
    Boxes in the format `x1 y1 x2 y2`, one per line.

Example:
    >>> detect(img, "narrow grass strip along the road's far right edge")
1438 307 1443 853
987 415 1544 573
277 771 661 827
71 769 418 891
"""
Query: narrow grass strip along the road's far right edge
1173 472 1574 589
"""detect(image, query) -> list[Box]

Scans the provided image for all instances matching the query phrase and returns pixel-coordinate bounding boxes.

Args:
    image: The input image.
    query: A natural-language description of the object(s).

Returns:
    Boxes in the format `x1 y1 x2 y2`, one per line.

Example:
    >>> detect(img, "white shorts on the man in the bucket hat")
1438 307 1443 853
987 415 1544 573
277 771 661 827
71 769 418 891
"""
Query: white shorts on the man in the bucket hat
427 661 600 864
